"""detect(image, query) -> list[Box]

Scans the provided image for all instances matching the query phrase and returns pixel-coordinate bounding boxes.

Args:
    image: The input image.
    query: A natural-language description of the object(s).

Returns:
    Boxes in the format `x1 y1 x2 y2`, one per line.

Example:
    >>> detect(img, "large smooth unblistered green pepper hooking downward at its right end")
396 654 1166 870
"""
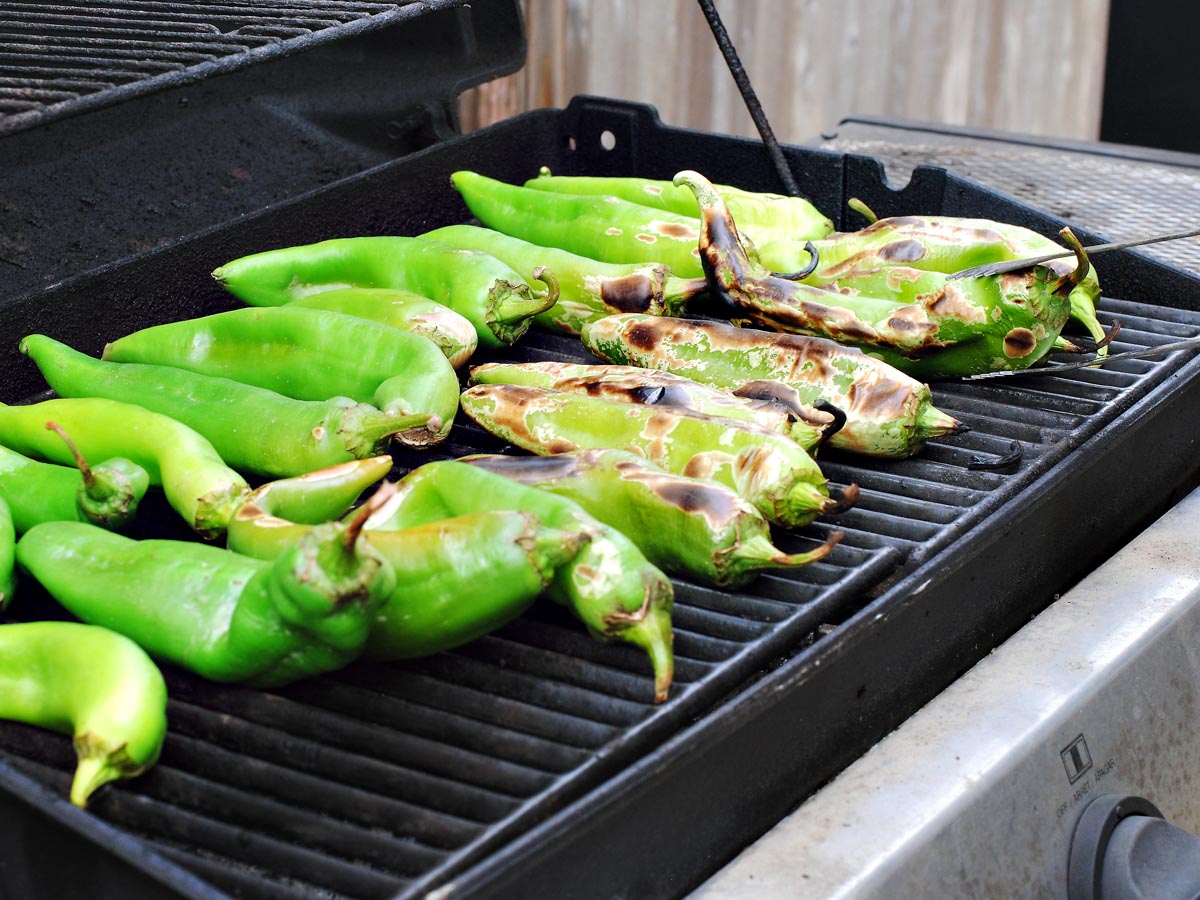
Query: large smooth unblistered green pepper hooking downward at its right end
103 306 458 446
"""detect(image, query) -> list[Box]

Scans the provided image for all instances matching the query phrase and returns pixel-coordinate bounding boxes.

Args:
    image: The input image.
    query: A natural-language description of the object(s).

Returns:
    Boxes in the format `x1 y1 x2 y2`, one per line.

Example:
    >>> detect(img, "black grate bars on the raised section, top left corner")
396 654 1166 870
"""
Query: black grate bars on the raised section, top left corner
0 0 463 134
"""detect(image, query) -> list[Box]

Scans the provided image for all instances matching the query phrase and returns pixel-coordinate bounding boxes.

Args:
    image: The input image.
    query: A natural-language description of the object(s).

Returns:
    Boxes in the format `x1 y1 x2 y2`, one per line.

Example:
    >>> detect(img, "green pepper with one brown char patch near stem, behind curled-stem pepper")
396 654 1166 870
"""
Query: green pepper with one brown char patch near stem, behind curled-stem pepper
421 224 708 335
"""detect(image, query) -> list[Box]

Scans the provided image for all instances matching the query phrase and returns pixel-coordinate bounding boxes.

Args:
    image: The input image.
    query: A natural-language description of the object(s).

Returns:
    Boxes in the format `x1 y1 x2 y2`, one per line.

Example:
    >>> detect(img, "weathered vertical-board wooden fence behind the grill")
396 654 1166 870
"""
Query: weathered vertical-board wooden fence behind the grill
461 0 1109 143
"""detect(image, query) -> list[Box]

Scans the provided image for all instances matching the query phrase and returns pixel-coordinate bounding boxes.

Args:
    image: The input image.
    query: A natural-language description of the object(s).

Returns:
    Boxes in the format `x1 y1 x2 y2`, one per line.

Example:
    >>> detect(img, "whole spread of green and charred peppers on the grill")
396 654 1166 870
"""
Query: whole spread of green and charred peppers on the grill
0 165 1103 805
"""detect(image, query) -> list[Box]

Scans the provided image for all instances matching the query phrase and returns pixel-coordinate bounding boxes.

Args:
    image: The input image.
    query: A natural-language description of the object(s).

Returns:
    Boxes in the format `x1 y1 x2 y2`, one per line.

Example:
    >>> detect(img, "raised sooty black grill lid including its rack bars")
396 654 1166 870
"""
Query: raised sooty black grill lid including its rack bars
0 0 524 300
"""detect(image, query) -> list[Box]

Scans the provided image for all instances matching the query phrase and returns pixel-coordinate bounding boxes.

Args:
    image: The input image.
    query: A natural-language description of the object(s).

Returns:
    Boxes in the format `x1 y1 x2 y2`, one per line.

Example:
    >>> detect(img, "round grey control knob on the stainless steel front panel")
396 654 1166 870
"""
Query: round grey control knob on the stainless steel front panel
1067 794 1200 900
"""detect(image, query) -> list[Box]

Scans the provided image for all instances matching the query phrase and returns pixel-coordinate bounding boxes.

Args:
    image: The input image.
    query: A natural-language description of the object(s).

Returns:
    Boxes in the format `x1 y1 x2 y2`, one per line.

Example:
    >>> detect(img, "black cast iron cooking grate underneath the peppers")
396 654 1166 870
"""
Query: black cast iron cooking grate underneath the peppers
0 290 1200 898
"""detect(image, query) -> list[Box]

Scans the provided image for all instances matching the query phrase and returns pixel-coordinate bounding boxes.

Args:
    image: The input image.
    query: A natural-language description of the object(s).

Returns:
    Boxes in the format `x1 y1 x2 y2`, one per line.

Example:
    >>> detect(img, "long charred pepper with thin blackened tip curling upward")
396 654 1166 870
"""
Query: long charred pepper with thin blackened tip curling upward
676 172 1088 378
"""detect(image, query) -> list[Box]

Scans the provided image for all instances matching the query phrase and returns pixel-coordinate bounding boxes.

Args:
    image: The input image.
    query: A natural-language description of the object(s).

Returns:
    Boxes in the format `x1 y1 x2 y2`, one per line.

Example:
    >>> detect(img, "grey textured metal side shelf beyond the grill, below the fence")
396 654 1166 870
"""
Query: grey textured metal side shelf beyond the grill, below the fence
818 120 1200 272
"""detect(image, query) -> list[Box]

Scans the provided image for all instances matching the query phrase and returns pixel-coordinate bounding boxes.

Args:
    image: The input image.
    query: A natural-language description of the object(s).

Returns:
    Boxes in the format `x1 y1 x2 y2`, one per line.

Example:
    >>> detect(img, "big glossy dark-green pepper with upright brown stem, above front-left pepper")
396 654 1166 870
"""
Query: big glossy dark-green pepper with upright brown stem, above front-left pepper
17 498 395 688
